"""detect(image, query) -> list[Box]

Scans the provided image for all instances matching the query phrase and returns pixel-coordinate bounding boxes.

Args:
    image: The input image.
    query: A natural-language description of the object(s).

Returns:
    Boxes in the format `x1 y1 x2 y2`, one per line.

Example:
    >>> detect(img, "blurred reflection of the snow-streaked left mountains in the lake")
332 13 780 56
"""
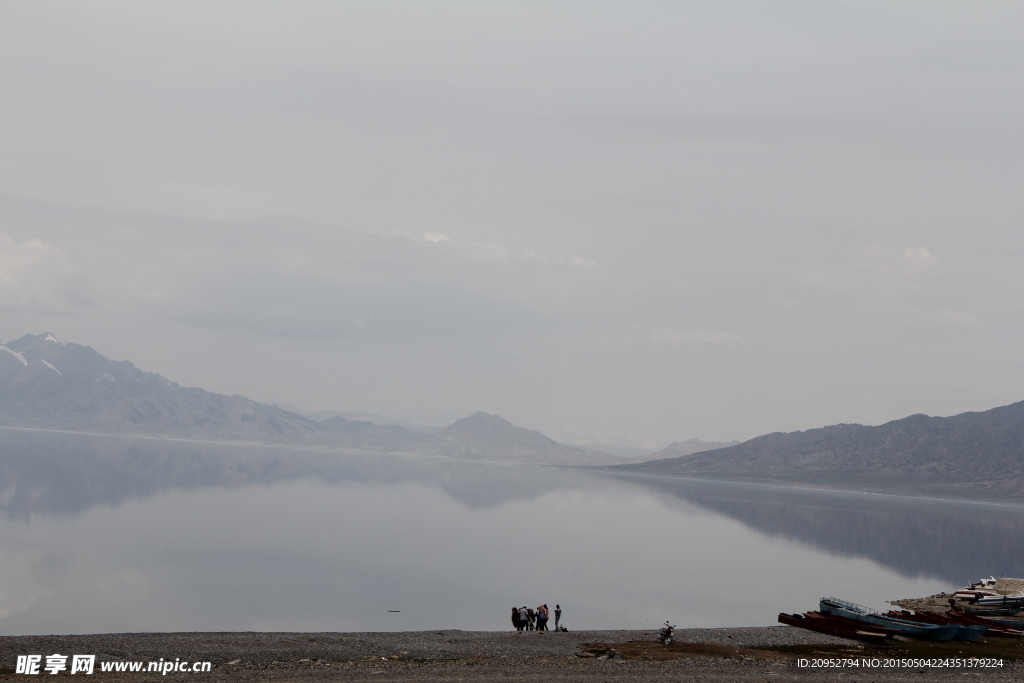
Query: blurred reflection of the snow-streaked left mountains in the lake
0 428 579 519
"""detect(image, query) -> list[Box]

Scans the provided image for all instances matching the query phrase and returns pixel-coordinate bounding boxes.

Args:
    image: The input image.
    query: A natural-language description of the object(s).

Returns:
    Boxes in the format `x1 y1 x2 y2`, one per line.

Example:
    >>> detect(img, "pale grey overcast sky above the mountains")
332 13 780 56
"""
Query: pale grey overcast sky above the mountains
0 0 1024 447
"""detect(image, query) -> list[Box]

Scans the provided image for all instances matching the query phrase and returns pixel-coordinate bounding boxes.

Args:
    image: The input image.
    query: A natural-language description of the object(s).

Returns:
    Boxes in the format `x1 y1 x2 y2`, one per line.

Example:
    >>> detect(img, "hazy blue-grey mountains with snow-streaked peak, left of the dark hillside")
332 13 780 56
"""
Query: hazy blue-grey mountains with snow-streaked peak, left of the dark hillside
0 332 642 466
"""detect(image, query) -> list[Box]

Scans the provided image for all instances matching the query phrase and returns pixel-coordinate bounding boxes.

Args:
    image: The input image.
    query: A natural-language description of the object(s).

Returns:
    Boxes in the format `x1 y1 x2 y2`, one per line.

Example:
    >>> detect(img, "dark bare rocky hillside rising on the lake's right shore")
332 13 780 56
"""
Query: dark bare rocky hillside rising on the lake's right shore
616 401 1024 495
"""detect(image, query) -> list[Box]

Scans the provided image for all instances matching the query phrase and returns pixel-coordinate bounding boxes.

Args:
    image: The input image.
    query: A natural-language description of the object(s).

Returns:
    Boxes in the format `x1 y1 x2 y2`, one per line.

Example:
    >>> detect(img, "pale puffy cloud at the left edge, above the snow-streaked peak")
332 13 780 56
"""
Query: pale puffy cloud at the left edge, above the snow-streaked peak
0 234 90 312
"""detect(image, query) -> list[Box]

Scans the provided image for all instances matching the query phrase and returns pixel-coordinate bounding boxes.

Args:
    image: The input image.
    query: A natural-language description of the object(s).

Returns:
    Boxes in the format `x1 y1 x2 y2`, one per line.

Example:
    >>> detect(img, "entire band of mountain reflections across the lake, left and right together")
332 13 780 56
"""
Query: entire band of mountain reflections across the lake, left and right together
0 429 1024 597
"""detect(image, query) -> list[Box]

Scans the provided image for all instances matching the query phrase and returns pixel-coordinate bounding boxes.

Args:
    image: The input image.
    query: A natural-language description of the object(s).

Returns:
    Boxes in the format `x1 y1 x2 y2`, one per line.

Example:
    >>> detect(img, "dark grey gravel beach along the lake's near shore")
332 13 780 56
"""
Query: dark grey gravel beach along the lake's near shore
0 626 1024 682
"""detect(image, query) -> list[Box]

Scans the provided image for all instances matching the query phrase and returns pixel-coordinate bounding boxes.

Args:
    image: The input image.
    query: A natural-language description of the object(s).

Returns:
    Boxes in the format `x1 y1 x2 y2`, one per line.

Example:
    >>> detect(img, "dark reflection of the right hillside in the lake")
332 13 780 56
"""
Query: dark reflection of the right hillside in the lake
598 476 1024 587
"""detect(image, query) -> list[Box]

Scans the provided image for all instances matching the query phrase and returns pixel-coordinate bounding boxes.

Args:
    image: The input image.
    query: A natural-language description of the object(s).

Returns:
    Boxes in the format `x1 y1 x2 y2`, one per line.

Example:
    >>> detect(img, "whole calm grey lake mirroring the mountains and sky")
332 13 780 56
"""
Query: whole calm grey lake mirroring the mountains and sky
0 429 1024 635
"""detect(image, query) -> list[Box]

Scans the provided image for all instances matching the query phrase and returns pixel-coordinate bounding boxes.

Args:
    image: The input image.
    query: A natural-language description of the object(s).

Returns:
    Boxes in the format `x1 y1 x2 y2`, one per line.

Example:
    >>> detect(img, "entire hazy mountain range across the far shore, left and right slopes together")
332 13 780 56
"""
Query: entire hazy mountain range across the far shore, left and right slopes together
8 333 1024 498
